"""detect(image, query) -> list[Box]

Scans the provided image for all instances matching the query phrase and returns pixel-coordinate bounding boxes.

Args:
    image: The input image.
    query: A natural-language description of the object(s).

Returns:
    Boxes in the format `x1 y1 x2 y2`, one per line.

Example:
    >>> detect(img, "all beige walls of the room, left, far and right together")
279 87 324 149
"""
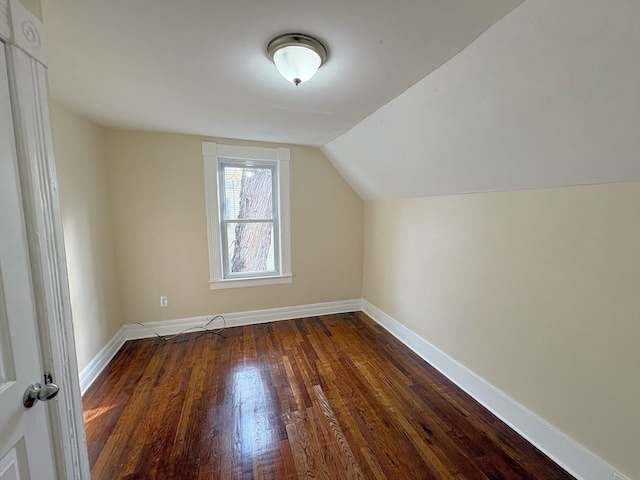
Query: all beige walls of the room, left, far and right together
51 98 640 478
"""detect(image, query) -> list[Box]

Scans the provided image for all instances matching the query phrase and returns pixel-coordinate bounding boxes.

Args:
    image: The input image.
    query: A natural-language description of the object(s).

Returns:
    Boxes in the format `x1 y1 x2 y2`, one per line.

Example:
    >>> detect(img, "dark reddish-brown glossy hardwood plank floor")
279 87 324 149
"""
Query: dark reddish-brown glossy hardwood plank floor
83 312 573 480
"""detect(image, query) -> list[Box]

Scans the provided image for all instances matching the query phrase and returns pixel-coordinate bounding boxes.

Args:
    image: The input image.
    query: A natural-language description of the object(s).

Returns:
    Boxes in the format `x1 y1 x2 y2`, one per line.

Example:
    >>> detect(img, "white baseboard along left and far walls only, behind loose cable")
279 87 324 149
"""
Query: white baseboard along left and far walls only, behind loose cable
80 299 362 395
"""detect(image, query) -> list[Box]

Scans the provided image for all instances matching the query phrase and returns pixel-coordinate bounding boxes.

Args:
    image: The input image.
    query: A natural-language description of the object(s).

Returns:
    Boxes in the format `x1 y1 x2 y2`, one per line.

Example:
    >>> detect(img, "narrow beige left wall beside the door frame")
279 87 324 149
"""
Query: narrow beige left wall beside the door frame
49 101 122 370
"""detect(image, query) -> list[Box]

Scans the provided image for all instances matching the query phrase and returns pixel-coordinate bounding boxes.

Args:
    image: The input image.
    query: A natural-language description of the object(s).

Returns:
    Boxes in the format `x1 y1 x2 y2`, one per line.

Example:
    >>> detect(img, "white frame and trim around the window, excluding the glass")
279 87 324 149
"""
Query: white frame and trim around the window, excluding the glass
202 142 293 290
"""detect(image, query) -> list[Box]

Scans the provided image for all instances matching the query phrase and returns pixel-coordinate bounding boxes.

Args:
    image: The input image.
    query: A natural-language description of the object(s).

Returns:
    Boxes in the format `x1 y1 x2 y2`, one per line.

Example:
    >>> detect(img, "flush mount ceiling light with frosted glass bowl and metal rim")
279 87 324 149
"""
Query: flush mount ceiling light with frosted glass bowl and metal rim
267 33 327 85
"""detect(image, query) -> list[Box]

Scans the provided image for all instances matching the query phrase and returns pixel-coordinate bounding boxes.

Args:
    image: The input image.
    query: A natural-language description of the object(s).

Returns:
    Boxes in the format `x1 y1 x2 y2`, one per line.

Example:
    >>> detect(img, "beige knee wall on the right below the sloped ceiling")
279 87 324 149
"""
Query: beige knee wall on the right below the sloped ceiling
363 182 640 478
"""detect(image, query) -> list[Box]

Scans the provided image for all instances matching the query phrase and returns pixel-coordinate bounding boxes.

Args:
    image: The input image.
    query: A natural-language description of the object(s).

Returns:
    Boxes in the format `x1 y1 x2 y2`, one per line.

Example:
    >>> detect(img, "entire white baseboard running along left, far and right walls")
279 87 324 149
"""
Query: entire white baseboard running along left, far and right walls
80 299 626 480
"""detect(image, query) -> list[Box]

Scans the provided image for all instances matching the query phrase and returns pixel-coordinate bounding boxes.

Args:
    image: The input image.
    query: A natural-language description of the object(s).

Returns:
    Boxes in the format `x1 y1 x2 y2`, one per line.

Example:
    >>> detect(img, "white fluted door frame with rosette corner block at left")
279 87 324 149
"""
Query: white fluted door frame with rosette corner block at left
0 0 90 479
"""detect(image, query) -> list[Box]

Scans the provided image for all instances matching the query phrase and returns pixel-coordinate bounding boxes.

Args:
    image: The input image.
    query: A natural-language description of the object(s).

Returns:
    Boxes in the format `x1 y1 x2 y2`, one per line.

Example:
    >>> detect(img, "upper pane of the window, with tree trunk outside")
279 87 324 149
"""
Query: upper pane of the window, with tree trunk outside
223 166 273 220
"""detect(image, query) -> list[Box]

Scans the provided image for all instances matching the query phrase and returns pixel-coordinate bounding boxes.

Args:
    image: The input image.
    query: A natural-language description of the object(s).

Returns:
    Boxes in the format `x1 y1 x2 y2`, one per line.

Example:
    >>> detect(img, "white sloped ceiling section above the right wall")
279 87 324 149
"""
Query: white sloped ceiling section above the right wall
322 0 640 199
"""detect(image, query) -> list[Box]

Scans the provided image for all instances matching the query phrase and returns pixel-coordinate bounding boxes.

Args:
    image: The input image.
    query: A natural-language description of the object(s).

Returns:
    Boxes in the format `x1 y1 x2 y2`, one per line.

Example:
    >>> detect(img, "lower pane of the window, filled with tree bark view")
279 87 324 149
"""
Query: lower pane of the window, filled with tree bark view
227 222 276 273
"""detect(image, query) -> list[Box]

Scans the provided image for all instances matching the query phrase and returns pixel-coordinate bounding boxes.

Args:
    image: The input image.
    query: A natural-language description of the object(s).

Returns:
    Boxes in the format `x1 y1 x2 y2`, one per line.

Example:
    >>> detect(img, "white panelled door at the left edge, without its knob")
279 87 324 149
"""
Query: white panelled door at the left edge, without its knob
0 42 56 480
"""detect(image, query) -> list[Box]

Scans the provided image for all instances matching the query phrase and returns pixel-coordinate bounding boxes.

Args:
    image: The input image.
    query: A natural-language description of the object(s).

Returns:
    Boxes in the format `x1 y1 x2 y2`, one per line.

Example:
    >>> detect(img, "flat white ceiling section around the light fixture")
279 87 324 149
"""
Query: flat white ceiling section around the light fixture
42 0 522 146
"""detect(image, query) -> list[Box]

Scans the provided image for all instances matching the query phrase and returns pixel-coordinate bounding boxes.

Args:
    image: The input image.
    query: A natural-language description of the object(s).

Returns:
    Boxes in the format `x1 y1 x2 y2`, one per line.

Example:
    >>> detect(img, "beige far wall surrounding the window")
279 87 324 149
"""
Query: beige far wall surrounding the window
106 130 364 323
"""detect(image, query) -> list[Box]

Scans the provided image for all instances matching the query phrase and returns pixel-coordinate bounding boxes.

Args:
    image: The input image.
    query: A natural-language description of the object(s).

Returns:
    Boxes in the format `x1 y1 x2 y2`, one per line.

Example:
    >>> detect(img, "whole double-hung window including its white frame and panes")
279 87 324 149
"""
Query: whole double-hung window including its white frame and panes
202 142 292 289
